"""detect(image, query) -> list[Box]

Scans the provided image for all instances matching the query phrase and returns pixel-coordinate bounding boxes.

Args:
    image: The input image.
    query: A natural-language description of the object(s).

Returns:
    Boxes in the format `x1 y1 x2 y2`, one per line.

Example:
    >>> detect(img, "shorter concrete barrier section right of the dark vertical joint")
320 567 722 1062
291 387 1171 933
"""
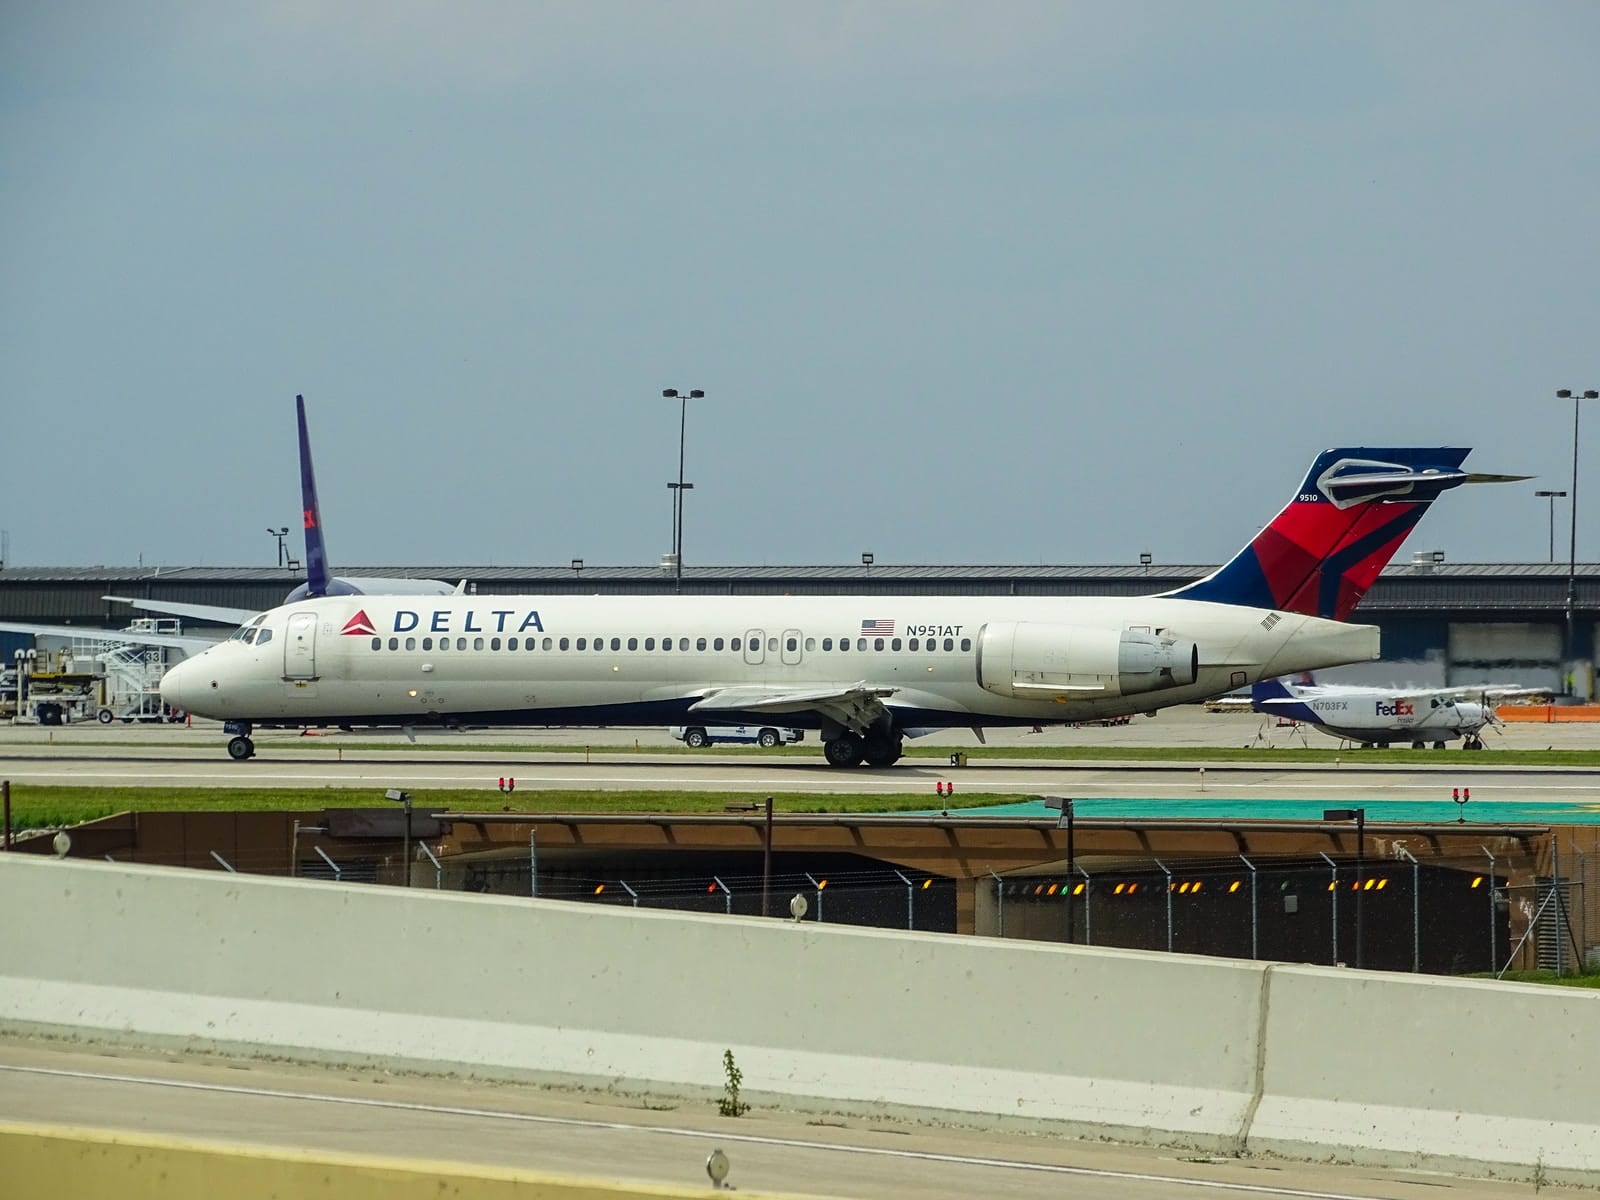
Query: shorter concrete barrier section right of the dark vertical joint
1250 966 1600 1176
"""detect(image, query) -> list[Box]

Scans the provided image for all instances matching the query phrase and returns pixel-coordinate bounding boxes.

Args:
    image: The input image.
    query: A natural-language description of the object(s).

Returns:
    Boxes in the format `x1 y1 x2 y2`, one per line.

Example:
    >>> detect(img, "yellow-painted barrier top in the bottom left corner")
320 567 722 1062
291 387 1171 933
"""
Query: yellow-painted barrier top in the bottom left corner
0 1122 806 1200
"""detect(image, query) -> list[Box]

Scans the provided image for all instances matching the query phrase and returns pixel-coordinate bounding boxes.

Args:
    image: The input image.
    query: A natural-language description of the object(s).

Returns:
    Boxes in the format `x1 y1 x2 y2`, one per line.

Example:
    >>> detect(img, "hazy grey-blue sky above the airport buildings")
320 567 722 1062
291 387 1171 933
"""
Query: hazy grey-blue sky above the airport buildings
0 0 1600 579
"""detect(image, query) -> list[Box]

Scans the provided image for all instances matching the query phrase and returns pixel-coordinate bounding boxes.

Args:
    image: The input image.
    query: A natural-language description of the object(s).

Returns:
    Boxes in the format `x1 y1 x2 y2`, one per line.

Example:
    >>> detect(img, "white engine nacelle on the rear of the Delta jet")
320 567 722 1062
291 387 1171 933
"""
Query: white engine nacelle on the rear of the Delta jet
978 621 1200 699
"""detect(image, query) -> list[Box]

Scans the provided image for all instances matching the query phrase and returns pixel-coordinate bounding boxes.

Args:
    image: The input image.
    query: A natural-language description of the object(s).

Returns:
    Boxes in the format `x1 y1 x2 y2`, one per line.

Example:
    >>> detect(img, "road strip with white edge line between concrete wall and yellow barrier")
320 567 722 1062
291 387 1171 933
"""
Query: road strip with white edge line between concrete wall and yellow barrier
0 1038 1529 1200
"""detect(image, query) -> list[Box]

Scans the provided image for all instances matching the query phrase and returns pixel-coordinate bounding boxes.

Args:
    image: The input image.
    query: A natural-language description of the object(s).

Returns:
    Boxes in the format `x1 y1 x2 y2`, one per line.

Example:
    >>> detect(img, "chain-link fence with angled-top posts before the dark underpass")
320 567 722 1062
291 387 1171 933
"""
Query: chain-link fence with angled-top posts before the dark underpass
268 830 1600 974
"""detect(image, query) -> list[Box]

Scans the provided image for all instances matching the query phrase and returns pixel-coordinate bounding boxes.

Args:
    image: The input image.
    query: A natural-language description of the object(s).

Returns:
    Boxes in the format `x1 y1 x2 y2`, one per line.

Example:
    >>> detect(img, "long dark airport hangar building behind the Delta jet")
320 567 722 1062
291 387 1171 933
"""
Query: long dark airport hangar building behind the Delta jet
0 550 1600 696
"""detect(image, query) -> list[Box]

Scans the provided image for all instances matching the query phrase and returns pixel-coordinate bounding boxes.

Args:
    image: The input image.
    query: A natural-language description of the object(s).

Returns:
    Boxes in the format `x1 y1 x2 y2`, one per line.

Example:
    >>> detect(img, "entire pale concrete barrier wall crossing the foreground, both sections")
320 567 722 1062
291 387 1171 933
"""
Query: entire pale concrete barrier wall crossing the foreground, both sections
0 856 1600 1182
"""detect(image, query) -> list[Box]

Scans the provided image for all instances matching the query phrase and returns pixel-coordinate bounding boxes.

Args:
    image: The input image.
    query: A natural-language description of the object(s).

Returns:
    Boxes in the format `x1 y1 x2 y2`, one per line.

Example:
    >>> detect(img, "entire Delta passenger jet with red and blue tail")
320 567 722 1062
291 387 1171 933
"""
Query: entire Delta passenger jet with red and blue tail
162 448 1510 766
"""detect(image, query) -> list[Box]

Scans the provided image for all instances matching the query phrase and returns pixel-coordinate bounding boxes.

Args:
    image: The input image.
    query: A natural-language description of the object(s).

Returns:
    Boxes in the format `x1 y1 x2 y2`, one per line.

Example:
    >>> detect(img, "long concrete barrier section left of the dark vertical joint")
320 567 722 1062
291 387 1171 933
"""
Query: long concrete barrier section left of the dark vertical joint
0 856 1261 1147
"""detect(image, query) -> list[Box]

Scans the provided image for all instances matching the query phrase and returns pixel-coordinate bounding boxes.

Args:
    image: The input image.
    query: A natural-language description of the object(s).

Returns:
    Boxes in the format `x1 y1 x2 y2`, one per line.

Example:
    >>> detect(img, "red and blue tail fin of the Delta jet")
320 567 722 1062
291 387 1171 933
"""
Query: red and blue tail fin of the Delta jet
1165 446 1472 621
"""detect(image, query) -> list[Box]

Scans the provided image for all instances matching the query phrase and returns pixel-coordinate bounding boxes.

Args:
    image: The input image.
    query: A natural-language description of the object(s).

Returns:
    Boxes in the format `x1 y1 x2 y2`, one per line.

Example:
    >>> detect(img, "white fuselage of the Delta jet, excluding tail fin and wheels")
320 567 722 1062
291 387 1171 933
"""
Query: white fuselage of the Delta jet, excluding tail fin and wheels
162 595 1378 728
